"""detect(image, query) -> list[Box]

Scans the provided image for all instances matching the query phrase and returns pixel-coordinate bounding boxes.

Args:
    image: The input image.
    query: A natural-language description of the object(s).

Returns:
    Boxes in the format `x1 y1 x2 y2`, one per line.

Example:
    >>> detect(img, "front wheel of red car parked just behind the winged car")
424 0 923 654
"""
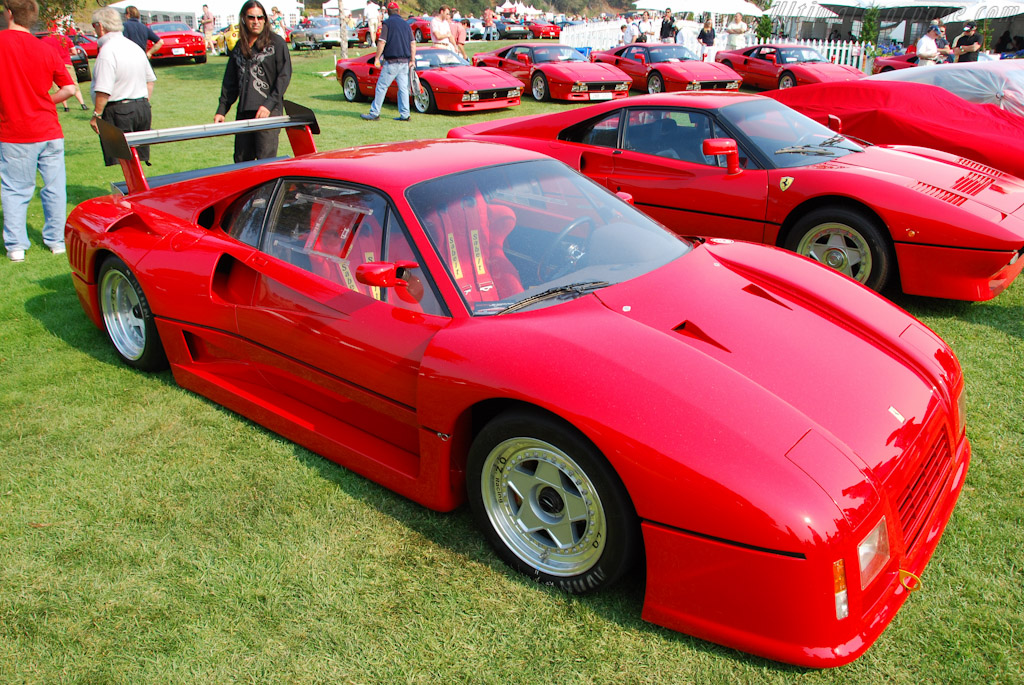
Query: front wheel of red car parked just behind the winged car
784 202 896 293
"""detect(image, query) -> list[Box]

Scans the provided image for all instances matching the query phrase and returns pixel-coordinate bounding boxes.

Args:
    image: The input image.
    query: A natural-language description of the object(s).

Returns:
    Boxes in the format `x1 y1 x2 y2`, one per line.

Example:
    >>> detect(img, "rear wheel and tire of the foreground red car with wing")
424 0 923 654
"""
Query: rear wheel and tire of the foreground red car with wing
97 255 167 371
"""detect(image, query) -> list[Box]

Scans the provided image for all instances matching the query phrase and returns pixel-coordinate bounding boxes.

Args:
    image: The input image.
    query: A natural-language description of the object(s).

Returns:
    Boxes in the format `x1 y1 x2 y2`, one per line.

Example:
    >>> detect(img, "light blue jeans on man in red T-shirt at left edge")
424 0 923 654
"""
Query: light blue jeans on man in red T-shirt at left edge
0 138 68 252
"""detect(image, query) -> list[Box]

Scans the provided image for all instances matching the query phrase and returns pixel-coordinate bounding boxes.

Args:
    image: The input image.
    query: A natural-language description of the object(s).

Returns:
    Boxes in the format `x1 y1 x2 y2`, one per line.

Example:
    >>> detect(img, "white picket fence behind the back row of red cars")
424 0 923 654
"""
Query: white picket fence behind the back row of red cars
560 22 870 71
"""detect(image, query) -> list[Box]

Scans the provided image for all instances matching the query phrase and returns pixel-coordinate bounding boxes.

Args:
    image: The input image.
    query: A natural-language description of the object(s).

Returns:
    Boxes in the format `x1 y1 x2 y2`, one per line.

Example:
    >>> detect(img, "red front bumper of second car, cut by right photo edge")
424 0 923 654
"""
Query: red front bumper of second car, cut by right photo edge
896 243 1024 301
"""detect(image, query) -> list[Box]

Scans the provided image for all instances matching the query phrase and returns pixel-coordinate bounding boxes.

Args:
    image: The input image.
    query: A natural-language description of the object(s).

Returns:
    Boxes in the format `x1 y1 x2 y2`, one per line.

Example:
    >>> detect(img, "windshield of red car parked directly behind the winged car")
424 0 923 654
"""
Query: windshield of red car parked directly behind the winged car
719 97 863 167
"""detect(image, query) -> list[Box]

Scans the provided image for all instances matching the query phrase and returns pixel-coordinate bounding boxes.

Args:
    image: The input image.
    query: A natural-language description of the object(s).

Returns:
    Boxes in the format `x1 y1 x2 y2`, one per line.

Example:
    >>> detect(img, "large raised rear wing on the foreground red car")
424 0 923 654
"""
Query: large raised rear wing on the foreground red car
96 100 319 194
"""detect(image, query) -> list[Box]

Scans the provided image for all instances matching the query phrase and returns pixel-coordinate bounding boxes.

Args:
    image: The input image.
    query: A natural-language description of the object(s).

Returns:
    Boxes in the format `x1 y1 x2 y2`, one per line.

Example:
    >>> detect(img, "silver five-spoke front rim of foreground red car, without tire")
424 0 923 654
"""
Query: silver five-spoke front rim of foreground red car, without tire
480 437 608 576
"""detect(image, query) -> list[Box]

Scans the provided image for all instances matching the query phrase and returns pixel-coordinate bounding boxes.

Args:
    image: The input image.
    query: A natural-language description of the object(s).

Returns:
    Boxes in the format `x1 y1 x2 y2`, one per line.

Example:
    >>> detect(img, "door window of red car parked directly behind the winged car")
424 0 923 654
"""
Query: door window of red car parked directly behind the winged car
623 110 717 165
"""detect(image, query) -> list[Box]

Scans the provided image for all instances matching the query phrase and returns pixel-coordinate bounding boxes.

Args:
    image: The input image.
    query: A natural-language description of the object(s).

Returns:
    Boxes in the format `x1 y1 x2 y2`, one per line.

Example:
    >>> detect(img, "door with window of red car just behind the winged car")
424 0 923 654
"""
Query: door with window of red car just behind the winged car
608 108 768 243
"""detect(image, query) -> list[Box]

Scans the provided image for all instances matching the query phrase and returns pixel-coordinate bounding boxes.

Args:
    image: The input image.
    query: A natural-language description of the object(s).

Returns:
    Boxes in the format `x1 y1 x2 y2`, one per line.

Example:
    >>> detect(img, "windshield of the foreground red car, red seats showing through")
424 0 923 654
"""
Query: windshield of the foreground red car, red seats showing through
406 161 690 315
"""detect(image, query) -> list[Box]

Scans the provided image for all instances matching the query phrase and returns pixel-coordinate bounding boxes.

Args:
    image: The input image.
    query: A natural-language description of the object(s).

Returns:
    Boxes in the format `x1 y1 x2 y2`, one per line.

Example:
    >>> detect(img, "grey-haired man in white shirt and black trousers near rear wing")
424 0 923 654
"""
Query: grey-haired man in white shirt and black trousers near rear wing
89 7 157 166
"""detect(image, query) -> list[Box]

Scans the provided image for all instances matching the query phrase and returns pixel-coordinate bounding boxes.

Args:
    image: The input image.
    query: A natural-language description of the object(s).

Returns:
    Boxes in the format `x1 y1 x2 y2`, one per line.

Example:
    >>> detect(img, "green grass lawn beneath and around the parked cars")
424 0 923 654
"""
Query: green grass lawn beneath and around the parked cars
0 44 1024 685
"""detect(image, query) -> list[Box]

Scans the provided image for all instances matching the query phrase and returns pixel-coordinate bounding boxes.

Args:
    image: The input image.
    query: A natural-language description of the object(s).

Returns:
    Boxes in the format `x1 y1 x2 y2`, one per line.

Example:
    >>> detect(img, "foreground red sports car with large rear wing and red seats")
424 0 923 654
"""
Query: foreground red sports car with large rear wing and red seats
67 108 971 667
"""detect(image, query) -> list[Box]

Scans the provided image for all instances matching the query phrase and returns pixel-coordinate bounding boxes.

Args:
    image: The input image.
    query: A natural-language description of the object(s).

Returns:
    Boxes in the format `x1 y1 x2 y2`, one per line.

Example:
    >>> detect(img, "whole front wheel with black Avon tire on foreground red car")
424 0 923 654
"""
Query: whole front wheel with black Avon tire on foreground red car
466 411 641 594
